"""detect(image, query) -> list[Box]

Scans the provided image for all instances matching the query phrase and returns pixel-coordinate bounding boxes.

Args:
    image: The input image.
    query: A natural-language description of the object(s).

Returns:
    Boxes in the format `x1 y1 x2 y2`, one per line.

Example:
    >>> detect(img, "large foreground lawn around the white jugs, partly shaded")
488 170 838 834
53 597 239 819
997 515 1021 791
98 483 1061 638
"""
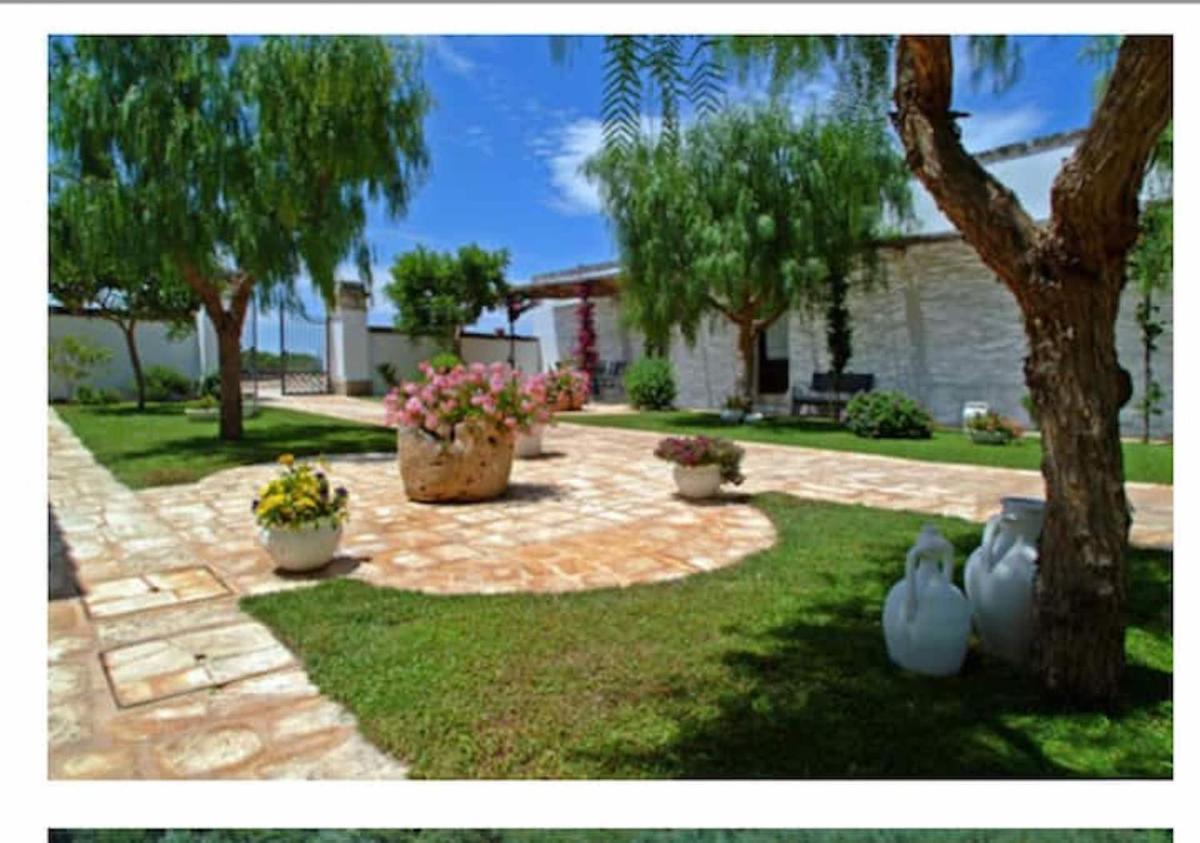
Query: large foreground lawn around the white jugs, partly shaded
242 494 1172 778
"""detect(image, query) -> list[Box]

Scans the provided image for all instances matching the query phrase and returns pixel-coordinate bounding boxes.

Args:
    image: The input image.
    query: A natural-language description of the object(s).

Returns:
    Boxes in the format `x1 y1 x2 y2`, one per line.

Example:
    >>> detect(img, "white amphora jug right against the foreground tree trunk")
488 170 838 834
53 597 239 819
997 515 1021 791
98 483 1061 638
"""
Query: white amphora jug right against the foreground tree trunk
964 497 1045 664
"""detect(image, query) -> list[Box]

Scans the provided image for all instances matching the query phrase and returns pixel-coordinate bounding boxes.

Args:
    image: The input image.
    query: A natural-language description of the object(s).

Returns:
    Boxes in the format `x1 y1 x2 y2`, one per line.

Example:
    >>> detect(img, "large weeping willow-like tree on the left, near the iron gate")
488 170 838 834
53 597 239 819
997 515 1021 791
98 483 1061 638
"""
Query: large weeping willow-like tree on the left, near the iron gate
50 36 428 440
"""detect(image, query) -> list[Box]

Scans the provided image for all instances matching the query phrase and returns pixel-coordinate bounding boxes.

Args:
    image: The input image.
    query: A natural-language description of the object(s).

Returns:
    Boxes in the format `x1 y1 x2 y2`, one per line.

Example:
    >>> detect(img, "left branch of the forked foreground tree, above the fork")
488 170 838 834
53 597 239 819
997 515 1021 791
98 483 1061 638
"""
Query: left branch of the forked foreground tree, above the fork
892 35 1039 293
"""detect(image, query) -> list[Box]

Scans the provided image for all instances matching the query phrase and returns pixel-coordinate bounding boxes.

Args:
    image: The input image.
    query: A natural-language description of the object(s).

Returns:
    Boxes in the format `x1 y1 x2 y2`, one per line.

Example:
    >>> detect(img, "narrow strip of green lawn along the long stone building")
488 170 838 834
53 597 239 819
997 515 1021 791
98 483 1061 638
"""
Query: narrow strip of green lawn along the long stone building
554 411 1175 484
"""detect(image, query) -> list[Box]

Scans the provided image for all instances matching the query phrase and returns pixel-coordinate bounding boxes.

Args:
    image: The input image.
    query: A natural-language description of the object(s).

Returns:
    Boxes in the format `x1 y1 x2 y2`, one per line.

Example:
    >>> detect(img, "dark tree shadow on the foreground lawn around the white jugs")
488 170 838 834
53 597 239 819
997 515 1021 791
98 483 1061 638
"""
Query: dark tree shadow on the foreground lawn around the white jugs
578 528 1174 779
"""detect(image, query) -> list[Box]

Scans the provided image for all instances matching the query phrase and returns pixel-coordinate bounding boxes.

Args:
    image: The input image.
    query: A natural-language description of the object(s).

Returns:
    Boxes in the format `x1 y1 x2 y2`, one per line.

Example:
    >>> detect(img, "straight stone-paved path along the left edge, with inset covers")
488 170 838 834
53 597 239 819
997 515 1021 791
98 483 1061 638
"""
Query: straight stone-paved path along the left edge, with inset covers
47 409 406 779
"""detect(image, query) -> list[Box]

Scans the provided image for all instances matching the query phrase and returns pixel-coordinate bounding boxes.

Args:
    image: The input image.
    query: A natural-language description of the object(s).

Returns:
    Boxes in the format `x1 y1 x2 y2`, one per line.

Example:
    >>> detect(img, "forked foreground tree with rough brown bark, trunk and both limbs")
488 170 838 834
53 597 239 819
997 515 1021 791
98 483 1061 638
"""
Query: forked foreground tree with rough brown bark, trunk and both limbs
893 36 1172 703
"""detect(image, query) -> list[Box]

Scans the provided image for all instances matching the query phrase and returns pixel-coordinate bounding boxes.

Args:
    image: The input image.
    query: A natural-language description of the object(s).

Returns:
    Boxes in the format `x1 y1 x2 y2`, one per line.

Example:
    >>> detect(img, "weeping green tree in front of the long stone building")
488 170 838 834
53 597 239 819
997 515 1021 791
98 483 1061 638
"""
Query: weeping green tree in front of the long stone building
587 108 820 400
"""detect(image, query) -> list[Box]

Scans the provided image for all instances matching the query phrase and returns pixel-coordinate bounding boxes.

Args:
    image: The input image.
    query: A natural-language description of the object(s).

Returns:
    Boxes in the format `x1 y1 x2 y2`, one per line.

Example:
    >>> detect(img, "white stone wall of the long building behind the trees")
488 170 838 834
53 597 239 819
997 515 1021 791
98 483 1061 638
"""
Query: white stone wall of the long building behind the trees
554 239 1174 436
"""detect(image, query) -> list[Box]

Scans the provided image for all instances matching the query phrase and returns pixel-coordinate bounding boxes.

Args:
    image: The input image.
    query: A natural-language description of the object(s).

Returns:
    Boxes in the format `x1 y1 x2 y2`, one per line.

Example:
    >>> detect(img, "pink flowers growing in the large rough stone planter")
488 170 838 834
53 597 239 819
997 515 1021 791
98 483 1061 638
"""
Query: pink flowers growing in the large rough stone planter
384 363 550 441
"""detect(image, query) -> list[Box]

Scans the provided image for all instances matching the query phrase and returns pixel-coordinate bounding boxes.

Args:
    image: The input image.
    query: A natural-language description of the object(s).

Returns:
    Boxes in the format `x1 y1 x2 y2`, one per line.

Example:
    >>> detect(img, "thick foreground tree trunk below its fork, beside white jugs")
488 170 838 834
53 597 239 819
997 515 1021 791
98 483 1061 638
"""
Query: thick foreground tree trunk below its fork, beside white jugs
1025 273 1132 701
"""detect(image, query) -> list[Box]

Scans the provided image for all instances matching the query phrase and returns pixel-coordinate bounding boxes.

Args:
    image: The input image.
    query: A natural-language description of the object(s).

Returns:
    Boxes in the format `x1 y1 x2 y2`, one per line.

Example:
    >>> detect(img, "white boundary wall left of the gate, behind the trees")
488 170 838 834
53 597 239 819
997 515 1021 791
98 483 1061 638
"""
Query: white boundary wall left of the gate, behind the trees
47 312 200 400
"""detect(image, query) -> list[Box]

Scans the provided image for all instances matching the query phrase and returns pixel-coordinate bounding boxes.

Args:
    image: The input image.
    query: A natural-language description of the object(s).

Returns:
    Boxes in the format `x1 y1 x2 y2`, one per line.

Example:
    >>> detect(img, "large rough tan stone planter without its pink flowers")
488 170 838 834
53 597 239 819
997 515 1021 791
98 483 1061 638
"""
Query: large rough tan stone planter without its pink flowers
397 424 514 503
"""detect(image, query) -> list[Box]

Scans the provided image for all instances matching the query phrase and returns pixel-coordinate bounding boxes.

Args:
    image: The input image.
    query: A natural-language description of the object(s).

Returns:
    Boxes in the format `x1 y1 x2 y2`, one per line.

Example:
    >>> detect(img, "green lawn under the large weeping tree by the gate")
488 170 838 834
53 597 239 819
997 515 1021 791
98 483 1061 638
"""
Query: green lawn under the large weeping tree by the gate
55 403 396 489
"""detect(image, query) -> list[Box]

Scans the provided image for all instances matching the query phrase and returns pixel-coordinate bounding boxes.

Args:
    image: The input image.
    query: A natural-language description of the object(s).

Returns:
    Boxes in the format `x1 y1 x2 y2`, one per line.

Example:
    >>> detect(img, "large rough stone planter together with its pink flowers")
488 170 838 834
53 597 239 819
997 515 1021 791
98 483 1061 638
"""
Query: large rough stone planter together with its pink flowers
384 363 535 502
